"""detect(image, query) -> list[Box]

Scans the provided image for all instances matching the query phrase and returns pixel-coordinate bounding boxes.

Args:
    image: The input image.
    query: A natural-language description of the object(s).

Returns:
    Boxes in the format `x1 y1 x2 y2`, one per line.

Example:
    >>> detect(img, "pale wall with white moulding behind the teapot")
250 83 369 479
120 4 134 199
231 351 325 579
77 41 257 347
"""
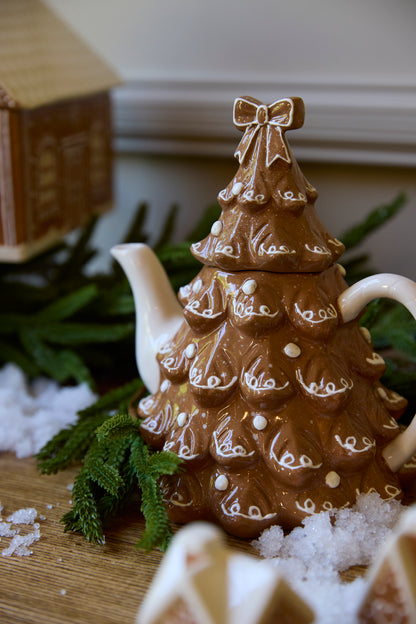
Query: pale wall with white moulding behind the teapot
47 0 416 279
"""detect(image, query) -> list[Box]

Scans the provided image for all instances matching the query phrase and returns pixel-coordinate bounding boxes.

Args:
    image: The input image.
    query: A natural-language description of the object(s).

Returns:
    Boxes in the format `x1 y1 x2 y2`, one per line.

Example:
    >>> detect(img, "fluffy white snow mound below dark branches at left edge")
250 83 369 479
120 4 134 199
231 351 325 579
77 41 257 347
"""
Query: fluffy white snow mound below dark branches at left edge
0 364 96 458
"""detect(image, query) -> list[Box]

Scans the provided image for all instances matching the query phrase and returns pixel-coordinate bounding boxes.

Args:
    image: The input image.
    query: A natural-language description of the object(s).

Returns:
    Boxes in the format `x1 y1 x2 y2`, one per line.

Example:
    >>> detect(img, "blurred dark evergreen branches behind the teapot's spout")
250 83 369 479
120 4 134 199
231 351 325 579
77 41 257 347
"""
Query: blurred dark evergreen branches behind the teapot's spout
0 204 214 387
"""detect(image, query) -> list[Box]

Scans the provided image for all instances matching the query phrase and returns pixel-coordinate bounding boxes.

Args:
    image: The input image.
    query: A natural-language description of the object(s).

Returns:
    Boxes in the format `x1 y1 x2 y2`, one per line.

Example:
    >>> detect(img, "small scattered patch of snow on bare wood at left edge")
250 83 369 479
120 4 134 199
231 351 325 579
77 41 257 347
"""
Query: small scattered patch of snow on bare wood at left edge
0 503 40 557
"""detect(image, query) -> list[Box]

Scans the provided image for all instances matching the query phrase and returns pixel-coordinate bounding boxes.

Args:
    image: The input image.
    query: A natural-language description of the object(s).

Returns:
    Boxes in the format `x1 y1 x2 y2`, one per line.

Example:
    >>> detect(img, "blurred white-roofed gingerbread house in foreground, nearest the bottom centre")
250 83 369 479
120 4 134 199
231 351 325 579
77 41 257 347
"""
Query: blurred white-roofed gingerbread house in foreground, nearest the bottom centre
136 522 315 624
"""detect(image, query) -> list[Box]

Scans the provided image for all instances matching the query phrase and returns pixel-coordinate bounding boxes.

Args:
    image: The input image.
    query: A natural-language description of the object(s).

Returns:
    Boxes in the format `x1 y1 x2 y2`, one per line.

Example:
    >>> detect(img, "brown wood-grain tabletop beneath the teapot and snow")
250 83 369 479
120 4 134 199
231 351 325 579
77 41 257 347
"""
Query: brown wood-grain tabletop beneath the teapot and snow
0 453 362 624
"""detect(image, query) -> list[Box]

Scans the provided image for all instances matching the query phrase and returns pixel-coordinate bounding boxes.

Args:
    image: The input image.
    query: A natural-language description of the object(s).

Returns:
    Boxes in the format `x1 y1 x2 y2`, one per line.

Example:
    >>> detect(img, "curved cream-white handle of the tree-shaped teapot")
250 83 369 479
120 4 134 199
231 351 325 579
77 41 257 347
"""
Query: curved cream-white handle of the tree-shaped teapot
338 273 416 472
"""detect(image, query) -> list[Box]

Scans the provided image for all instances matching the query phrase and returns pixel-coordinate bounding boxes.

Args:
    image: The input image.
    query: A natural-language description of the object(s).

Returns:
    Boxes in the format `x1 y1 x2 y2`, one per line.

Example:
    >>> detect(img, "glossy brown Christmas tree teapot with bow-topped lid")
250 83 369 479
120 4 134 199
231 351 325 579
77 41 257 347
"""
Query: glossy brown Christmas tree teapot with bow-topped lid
112 97 416 537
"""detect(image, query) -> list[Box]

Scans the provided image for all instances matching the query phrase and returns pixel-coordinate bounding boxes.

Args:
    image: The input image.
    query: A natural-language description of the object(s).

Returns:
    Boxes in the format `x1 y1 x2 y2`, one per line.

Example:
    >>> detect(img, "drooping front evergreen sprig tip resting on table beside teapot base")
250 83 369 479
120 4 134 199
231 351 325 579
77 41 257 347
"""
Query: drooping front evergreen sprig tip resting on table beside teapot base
62 412 181 550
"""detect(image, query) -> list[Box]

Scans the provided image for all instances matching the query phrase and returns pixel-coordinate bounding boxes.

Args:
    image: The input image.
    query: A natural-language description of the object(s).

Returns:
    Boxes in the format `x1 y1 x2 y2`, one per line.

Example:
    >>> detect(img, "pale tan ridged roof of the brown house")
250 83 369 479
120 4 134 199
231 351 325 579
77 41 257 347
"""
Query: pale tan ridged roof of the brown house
0 0 120 108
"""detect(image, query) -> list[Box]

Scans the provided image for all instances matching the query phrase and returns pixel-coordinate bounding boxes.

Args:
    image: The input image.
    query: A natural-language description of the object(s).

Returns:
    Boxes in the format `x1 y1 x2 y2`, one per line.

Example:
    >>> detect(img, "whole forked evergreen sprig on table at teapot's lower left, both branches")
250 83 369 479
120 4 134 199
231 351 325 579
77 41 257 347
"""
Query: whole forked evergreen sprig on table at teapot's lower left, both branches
37 380 181 550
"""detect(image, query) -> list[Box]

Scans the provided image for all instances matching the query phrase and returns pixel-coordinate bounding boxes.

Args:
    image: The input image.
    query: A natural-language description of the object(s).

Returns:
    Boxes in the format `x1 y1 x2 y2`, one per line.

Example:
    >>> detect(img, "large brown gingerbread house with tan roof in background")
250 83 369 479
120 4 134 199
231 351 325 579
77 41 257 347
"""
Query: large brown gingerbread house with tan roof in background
0 0 120 262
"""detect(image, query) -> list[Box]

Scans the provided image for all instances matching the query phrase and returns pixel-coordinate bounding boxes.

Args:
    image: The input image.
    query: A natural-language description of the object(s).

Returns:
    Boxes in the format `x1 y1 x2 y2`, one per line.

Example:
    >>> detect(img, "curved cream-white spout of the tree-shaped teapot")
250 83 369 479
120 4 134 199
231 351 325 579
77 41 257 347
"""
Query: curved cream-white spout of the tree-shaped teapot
111 243 183 393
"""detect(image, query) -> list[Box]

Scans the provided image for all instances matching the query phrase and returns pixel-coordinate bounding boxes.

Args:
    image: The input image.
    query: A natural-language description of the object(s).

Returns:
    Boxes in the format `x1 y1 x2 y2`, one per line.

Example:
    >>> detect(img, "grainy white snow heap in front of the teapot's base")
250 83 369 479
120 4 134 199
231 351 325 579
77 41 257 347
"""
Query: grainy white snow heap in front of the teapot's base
250 493 404 624
